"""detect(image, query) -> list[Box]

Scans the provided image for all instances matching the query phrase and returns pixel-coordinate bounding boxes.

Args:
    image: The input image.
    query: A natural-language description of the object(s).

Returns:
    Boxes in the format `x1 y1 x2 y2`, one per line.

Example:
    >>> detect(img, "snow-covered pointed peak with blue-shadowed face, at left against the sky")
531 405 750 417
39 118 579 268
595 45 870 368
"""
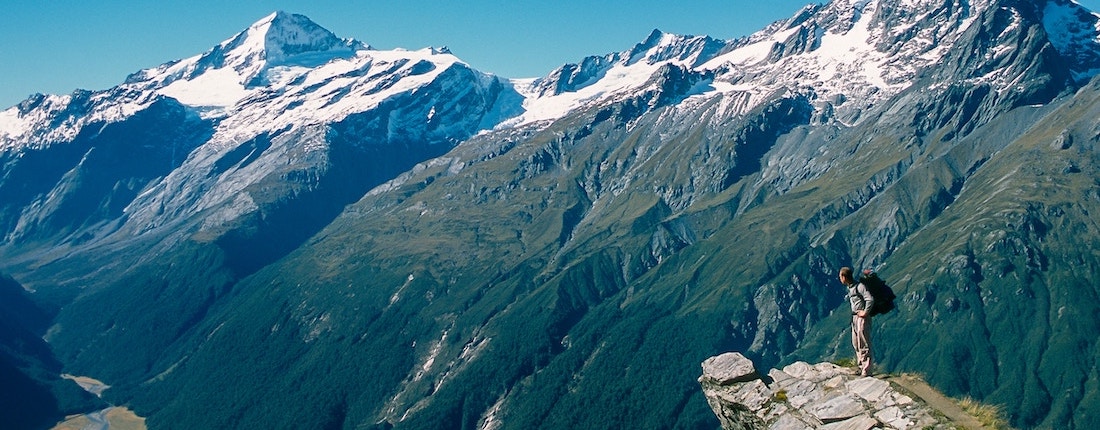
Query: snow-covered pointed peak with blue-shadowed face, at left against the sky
0 12 484 148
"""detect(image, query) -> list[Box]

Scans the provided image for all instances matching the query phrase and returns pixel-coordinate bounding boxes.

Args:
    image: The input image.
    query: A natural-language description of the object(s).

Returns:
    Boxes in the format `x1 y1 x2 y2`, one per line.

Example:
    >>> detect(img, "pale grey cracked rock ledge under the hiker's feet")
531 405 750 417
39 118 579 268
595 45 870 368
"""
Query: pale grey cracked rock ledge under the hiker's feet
699 352 957 430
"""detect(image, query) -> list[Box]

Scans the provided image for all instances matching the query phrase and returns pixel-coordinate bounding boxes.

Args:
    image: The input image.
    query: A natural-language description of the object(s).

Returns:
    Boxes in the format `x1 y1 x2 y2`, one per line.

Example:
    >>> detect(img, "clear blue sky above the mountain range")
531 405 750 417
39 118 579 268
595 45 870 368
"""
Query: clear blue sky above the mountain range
0 0 1100 109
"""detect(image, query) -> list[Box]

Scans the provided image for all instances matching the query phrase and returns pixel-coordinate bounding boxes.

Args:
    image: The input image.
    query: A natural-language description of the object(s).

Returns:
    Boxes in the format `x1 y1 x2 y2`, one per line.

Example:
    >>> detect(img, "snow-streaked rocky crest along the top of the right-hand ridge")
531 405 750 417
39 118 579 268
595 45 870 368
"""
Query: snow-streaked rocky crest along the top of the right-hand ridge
510 0 1086 126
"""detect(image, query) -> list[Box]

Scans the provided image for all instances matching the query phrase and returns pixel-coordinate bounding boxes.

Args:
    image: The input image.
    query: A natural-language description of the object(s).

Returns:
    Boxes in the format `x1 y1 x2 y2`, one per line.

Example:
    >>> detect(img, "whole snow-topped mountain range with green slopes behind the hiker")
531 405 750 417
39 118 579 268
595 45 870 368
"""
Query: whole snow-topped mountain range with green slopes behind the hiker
0 0 1100 429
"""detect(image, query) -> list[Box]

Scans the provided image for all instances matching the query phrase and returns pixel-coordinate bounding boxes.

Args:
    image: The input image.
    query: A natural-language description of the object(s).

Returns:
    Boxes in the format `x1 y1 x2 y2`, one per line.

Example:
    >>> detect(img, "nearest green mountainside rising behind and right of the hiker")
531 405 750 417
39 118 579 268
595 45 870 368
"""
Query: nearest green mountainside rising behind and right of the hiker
800 79 1100 427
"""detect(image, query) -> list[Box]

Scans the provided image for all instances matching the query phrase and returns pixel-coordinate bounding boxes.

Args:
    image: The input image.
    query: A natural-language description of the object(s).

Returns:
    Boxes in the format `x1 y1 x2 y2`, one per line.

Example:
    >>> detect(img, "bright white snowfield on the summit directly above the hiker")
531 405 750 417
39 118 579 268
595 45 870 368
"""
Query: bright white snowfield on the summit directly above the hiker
702 0 989 122
